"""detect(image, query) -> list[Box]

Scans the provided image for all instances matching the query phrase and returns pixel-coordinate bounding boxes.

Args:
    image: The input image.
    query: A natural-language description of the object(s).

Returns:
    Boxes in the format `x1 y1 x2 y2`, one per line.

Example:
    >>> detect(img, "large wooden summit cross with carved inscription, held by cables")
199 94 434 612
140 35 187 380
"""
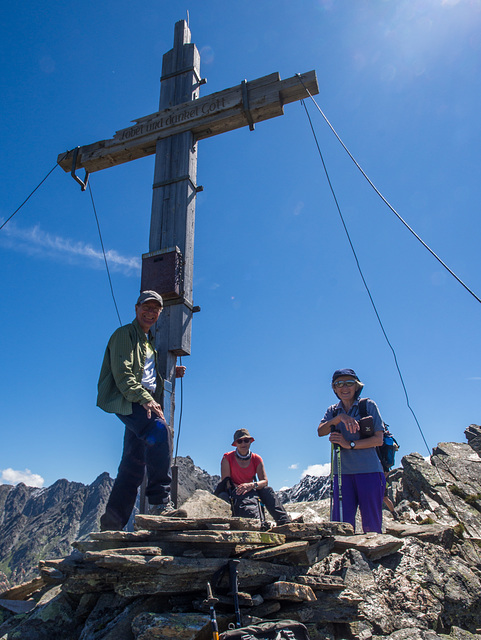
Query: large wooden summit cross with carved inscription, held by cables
57 20 319 476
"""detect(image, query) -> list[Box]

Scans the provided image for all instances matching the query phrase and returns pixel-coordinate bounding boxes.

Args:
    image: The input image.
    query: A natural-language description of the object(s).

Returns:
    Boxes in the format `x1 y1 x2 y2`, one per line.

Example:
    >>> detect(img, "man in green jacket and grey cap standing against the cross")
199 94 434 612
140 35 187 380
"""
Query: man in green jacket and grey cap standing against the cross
97 291 185 531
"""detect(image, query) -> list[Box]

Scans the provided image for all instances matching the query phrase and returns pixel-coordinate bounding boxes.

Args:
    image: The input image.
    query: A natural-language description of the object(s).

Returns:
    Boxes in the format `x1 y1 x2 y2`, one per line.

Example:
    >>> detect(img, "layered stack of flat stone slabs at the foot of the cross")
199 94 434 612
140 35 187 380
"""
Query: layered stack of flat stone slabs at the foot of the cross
40 515 403 624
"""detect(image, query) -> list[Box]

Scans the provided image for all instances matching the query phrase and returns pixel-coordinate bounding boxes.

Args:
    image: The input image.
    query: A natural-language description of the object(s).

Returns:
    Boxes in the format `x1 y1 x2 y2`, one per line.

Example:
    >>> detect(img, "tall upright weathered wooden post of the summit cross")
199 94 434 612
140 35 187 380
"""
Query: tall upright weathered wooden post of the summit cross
149 20 200 502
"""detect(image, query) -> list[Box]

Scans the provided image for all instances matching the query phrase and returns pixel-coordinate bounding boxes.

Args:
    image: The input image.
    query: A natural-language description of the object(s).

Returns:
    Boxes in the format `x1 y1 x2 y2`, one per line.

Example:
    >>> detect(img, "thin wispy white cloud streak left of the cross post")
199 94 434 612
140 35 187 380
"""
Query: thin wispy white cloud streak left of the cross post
0 223 140 276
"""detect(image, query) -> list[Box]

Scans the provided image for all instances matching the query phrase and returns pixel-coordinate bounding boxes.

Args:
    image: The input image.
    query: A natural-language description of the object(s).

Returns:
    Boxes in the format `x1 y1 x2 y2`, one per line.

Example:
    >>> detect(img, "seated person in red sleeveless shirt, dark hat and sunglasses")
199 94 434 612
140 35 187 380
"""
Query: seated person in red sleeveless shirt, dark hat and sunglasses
214 429 291 525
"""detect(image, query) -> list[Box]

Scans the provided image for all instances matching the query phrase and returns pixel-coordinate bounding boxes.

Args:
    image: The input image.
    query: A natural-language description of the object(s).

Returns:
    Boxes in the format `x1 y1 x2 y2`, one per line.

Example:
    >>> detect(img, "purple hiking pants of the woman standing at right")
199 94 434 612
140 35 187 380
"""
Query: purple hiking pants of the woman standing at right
331 472 386 533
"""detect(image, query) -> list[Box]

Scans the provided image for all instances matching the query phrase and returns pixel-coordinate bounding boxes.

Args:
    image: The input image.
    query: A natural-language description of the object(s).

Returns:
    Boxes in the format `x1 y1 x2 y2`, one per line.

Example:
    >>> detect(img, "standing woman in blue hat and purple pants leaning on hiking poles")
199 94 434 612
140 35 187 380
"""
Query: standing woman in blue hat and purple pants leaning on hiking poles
317 369 386 533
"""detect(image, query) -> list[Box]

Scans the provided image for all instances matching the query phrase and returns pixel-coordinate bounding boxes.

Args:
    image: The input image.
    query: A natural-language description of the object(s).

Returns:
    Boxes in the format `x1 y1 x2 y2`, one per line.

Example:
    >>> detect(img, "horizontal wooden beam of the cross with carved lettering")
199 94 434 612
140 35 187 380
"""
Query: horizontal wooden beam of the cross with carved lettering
57 71 319 172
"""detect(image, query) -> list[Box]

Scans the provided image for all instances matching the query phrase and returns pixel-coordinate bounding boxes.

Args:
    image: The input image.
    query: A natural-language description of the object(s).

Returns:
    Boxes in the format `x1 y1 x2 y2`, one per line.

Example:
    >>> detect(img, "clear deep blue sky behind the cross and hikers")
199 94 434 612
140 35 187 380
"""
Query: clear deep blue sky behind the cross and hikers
0 0 481 489
